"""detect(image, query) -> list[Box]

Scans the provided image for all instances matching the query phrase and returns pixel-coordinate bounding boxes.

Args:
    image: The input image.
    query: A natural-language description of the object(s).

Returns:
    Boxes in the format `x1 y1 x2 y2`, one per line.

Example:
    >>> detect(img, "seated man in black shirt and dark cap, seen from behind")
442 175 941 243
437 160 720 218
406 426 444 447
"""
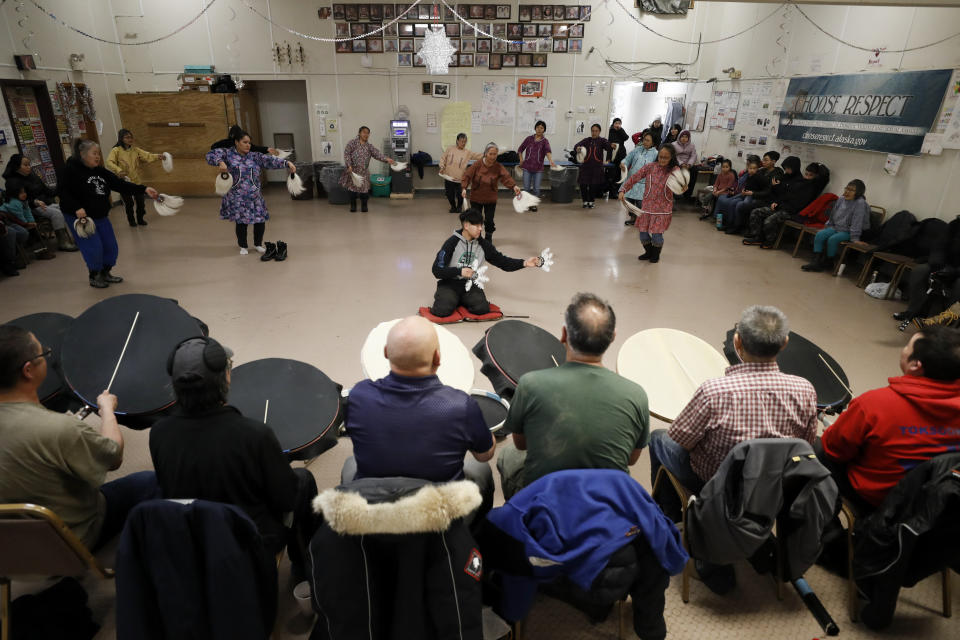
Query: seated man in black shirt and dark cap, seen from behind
150 337 317 579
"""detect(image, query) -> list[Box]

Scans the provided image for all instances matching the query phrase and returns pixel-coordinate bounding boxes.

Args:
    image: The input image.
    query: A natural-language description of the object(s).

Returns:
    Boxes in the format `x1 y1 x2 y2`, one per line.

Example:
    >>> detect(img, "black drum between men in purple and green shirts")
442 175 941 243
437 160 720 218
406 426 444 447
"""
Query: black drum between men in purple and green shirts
473 320 567 400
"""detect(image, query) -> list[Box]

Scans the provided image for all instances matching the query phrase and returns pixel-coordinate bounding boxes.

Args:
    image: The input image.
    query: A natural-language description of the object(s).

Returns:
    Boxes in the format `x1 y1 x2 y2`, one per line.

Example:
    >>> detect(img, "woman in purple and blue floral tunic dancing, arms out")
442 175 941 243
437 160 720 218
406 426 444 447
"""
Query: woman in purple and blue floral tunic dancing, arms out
207 129 297 256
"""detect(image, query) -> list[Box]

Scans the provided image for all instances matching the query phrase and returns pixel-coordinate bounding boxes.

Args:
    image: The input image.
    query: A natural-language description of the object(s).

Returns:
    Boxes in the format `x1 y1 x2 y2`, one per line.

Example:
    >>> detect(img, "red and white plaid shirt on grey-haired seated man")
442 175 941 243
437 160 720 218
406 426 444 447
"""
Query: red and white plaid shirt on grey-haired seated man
667 362 817 481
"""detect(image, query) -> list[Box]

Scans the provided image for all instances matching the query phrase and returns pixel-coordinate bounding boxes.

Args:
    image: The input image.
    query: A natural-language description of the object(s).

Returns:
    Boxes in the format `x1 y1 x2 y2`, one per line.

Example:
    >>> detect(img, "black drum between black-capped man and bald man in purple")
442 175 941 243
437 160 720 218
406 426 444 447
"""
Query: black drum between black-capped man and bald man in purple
229 358 343 460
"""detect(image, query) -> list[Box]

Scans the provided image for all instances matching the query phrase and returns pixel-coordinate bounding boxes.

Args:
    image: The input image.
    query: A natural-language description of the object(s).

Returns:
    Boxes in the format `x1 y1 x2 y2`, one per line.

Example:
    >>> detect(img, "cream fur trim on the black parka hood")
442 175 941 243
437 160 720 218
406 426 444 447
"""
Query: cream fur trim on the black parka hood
313 478 481 535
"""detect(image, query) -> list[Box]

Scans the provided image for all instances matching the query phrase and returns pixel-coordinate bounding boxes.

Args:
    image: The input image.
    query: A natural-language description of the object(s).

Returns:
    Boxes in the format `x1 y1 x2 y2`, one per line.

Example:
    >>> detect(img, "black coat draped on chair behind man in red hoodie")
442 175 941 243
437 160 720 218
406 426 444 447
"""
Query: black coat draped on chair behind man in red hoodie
853 453 960 629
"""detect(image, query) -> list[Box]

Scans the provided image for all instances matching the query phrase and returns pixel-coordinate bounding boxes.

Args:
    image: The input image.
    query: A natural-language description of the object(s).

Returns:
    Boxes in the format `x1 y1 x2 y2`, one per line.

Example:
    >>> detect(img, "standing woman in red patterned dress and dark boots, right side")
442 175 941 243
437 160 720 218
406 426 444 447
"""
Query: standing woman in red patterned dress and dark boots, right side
620 145 679 262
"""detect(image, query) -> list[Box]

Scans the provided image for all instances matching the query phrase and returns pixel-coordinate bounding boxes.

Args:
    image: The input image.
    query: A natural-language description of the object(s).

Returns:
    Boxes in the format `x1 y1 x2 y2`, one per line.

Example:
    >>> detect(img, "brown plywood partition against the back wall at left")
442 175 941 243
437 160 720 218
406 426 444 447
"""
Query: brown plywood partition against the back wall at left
117 92 256 196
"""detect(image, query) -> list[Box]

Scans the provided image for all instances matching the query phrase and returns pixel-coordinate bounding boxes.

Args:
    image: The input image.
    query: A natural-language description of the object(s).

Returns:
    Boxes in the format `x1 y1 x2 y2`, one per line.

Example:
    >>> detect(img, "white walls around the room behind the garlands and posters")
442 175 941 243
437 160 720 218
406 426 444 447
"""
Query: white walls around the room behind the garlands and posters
0 0 960 218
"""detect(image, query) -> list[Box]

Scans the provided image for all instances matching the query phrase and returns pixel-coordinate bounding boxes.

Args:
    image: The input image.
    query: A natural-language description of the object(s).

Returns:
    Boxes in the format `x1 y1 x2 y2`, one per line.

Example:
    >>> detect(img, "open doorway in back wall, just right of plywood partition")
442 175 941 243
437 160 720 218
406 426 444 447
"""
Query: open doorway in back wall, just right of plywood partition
248 80 313 182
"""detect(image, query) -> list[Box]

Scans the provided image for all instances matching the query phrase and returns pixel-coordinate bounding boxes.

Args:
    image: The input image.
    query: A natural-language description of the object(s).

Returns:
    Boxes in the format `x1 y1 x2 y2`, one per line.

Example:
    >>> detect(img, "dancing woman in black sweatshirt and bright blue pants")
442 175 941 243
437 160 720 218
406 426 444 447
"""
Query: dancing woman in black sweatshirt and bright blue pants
57 140 158 289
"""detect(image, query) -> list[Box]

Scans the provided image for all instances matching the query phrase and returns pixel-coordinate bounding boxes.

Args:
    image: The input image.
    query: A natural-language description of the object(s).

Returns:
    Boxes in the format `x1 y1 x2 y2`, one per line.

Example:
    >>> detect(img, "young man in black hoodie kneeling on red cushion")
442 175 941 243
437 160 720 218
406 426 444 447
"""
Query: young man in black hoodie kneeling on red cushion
430 209 541 318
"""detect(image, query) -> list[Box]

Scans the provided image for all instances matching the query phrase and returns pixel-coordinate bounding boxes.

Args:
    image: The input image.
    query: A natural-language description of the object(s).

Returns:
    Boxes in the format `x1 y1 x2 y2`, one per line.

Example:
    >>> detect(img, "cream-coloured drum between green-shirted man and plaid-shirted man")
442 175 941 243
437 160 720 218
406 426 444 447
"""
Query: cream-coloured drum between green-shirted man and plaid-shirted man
617 329 728 422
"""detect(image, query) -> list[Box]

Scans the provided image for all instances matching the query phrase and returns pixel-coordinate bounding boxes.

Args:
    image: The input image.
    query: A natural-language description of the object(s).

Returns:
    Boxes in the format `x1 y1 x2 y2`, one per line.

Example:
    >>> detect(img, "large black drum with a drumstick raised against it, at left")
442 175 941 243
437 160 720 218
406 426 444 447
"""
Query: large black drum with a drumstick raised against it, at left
61 293 201 416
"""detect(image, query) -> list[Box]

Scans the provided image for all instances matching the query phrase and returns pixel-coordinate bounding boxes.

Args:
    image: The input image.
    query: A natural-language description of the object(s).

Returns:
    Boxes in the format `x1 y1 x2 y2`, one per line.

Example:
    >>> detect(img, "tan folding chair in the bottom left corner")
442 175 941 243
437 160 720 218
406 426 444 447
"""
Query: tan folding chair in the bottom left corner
0 504 114 640
